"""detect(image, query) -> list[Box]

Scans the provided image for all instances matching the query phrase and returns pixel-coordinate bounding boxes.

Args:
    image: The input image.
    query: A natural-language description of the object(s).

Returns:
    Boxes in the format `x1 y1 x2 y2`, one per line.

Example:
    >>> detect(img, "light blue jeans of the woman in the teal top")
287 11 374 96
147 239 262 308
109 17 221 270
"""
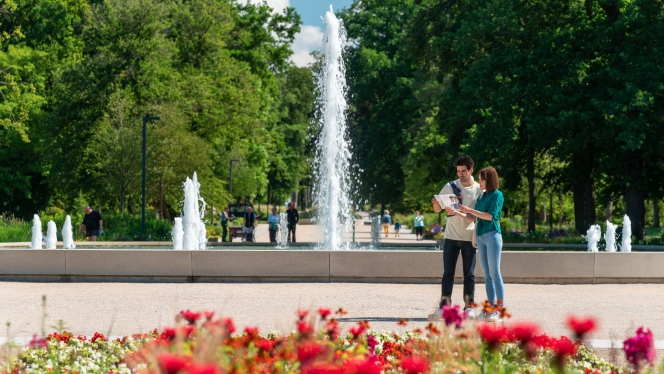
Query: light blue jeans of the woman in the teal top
477 230 505 305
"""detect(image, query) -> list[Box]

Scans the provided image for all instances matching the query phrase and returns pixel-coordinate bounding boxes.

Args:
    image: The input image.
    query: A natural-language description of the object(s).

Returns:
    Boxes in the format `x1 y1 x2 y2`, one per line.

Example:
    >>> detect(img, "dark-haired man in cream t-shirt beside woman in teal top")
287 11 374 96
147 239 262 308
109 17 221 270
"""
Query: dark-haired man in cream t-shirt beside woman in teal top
429 156 482 318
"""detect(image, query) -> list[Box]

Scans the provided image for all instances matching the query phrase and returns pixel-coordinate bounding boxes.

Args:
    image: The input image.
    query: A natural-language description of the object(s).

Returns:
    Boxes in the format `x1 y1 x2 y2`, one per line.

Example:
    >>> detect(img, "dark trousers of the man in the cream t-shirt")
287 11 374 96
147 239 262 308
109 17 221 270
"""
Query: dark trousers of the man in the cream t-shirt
440 239 477 307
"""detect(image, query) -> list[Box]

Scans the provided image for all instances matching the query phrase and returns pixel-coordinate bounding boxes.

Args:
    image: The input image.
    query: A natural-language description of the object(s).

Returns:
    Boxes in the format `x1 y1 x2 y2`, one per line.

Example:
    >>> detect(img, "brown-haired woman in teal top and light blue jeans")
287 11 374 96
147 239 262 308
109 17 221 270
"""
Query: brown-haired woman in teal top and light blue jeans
459 167 505 319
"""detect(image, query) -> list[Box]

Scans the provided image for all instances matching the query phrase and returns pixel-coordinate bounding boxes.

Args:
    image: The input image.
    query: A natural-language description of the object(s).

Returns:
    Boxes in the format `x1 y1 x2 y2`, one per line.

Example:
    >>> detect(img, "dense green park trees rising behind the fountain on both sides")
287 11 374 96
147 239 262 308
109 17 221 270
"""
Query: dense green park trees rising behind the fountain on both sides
0 0 664 243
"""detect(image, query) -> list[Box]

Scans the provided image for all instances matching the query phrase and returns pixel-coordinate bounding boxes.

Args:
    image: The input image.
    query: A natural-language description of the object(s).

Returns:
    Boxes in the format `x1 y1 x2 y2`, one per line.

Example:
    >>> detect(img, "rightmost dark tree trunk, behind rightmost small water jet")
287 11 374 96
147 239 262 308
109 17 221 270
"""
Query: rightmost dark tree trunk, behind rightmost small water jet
625 152 646 240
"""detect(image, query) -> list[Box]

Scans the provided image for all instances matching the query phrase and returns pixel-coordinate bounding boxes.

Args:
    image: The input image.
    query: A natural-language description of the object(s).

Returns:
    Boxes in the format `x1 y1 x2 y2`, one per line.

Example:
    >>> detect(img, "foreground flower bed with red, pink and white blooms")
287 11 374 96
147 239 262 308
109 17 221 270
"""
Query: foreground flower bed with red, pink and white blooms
0 307 655 374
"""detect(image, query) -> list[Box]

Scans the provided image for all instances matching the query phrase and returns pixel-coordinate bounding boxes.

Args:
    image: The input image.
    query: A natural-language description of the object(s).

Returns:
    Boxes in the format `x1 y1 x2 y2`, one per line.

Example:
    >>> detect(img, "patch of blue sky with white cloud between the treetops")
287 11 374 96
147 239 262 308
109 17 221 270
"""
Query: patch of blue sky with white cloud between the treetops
252 0 353 66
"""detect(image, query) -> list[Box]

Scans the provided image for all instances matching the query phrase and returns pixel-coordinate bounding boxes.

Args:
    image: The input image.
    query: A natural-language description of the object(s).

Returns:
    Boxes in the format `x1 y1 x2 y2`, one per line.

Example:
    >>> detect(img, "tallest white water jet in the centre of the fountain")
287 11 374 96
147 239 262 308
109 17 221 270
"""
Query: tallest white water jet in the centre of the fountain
314 6 353 249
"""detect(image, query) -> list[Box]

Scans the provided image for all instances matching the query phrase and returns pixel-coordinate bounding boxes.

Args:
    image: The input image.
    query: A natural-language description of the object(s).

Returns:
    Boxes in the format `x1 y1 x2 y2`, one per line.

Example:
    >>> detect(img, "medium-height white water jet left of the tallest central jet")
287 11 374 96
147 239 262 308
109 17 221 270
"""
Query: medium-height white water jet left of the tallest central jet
182 172 207 250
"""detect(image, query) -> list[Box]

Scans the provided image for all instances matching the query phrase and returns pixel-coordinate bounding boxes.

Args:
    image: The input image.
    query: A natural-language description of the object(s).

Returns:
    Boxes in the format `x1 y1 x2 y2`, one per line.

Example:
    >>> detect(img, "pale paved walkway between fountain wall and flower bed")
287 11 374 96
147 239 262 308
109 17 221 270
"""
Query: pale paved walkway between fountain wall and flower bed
0 282 664 340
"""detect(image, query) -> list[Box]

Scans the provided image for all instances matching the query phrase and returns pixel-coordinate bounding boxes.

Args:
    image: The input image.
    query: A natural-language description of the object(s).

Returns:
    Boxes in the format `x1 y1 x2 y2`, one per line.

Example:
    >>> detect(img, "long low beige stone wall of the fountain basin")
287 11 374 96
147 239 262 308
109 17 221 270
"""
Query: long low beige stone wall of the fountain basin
0 249 664 284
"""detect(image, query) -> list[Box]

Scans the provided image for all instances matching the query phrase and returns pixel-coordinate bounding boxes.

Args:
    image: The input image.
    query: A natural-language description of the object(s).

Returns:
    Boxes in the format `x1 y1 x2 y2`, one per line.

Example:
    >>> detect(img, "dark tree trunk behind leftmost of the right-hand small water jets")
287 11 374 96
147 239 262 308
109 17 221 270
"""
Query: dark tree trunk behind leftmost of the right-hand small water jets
573 145 597 235
